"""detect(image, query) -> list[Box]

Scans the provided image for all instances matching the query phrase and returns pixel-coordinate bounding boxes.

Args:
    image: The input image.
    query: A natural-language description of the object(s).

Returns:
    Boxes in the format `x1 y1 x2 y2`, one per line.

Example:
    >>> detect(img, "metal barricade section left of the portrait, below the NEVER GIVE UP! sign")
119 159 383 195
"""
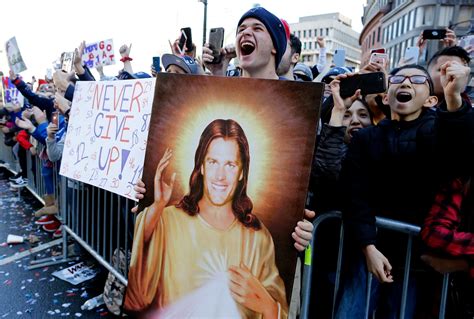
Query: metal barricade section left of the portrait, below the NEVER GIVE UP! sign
0 136 131 286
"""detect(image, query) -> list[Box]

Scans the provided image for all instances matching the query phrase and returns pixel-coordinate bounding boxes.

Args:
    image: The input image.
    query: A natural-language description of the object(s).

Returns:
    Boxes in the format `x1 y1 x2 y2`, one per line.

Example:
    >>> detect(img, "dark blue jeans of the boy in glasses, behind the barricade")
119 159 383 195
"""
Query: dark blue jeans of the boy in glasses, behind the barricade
335 254 416 319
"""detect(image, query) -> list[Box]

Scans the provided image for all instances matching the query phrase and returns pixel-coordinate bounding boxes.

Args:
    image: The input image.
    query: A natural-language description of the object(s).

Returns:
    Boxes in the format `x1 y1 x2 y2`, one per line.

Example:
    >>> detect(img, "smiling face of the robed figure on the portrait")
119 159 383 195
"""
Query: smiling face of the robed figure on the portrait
201 138 243 206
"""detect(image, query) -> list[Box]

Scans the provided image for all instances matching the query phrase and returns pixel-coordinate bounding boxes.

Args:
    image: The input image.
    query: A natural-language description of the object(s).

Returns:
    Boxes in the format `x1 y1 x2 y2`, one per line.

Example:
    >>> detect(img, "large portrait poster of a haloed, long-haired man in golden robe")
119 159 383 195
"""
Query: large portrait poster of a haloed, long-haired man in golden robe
124 73 323 318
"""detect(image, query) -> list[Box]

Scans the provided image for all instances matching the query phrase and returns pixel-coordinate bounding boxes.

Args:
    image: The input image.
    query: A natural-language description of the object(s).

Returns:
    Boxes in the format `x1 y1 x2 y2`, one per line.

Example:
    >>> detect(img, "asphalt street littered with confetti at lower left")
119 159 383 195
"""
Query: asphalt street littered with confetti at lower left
0 169 115 318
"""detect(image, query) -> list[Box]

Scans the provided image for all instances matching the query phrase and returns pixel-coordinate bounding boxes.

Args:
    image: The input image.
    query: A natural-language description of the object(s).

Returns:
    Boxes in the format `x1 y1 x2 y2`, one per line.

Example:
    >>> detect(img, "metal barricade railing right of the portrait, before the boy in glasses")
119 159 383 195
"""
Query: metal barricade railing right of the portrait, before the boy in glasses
301 211 449 319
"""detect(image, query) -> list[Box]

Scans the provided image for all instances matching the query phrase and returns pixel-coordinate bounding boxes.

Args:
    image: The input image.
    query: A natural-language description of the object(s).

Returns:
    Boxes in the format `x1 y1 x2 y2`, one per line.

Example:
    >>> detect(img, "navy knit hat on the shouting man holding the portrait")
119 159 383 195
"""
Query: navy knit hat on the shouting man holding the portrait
237 7 287 69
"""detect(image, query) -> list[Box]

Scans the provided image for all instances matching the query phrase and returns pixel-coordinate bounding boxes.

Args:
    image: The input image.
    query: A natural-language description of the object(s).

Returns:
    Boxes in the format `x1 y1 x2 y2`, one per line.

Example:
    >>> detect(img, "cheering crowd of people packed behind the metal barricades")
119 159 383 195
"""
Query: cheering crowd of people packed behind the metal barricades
0 7 474 318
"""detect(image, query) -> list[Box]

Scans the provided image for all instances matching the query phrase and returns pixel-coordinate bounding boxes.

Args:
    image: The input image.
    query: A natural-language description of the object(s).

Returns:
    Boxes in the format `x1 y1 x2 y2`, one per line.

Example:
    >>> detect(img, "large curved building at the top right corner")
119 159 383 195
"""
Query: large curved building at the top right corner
359 0 474 68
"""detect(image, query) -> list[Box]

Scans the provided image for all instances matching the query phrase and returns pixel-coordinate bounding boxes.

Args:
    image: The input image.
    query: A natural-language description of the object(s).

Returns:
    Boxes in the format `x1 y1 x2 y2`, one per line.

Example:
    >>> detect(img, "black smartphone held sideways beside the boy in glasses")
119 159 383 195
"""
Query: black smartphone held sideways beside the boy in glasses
340 72 387 98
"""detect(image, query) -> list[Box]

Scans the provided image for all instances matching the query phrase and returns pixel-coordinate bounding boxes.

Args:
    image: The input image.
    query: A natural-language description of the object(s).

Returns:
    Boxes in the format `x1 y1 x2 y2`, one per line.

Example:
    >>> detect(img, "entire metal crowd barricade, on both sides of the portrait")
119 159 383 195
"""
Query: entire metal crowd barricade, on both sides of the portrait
0 134 449 319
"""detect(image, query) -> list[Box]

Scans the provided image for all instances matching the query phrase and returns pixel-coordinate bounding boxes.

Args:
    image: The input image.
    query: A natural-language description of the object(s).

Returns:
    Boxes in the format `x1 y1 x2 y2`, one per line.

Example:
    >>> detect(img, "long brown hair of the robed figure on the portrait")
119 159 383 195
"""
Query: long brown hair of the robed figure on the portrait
176 119 261 229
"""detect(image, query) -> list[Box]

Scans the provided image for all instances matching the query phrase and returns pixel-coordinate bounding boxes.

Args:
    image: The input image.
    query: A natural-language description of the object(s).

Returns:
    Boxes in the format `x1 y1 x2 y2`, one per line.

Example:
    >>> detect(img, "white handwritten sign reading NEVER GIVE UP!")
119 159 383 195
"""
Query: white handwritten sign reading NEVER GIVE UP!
60 78 155 200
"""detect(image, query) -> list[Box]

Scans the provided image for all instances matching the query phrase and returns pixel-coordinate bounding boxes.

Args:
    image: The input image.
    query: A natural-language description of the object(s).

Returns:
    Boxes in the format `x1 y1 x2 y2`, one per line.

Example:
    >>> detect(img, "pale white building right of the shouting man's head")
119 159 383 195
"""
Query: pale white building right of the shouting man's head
290 13 361 68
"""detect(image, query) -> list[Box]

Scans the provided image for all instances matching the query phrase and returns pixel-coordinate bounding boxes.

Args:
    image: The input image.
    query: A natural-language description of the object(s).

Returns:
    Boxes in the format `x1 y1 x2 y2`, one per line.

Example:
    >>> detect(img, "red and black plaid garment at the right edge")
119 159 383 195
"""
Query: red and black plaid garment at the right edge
421 179 474 278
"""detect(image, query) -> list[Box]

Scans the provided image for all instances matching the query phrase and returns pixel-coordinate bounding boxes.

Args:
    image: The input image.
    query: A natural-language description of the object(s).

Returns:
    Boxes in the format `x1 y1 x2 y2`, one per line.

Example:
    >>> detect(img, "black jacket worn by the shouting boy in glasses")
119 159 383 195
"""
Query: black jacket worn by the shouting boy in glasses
341 103 474 246
